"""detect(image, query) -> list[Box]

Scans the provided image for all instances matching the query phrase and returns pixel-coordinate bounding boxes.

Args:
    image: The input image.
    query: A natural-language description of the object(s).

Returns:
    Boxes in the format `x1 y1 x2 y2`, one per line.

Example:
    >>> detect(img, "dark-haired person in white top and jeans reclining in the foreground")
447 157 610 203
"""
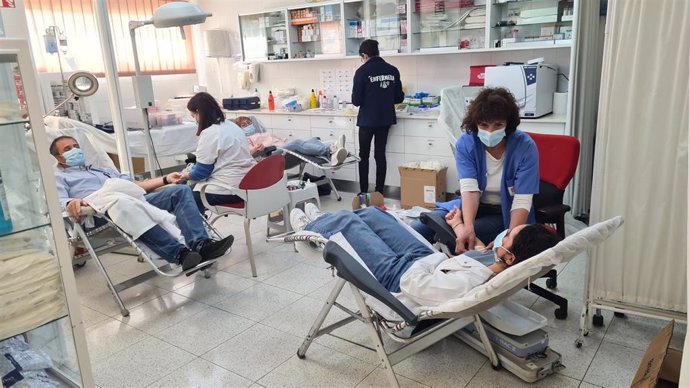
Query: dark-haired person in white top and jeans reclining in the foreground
290 204 559 313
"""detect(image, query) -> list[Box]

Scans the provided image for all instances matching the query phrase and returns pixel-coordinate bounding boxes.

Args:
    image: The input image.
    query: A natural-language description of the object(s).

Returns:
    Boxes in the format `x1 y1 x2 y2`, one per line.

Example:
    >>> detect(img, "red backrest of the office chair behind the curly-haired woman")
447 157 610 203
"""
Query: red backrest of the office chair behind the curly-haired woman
529 133 580 238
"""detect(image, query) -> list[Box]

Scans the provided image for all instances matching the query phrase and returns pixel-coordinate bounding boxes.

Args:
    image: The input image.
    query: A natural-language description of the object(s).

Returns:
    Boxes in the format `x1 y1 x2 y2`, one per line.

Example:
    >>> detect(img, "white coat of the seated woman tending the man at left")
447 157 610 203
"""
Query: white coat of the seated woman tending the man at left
195 120 256 194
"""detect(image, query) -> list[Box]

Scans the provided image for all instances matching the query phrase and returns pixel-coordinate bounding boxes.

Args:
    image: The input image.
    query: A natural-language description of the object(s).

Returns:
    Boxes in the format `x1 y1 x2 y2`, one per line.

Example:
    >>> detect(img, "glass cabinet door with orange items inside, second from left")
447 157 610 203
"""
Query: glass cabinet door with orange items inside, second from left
289 3 344 58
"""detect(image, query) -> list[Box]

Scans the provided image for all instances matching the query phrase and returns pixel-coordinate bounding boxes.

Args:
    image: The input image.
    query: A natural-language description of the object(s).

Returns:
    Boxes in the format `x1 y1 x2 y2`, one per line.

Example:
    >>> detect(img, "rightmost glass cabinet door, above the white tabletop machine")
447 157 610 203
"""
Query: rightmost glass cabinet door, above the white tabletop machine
490 0 574 47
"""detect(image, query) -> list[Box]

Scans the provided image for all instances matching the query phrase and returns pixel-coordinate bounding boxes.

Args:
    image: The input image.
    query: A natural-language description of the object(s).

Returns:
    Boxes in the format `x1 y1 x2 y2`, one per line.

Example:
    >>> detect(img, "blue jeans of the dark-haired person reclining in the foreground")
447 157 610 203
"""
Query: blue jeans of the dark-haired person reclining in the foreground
305 207 433 292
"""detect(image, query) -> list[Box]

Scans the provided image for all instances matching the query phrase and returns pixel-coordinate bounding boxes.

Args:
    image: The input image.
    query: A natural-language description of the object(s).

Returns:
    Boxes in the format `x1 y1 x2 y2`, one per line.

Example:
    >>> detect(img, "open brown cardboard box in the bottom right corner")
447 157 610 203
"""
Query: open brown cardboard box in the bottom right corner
630 320 683 388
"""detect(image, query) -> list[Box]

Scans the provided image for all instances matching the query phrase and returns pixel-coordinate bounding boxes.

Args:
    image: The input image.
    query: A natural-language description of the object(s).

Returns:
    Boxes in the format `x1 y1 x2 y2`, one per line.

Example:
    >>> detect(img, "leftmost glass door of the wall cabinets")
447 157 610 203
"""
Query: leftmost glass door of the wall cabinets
240 11 290 61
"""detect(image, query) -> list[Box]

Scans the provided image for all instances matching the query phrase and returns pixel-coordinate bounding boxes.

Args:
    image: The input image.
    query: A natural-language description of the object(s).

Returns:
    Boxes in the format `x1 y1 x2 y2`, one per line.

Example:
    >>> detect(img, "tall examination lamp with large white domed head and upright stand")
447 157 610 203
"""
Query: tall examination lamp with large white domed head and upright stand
129 1 211 176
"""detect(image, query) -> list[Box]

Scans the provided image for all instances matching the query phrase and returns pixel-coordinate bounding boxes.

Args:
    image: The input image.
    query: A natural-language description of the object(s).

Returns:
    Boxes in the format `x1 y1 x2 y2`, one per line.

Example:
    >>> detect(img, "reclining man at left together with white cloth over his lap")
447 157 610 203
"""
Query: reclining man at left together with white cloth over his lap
50 136 234 276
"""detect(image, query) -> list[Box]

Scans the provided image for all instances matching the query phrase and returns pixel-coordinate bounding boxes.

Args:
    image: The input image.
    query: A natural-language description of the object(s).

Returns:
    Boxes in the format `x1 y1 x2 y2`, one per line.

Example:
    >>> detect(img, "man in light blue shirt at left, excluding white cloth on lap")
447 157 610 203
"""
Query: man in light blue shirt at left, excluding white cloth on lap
50 136 234 276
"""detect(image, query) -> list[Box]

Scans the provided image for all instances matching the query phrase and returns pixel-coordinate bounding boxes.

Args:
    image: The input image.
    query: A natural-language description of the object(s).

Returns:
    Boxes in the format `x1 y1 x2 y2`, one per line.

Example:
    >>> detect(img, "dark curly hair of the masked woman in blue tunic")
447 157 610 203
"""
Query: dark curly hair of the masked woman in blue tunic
461 88 520 136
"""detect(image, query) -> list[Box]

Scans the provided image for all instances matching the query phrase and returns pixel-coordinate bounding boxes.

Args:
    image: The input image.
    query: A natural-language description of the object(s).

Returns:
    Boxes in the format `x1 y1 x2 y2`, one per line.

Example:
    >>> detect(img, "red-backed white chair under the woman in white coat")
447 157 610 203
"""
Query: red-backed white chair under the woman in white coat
200 155 290 277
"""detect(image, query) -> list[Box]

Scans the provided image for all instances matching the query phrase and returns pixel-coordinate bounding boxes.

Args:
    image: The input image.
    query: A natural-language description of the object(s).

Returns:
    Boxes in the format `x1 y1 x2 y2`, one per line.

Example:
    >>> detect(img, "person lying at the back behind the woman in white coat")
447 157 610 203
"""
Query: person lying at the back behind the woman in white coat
235 116 347 166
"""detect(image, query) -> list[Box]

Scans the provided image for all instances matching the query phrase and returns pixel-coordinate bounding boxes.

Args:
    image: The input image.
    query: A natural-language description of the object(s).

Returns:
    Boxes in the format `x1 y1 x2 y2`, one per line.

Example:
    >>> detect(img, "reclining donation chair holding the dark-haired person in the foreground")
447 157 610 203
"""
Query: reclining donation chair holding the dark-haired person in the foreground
285 217 623 386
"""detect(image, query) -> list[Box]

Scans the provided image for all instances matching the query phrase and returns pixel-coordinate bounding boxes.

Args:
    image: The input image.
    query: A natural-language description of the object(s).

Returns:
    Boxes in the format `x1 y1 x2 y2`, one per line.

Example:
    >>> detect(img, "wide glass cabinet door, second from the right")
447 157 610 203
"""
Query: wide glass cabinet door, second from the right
411 0 486 52
